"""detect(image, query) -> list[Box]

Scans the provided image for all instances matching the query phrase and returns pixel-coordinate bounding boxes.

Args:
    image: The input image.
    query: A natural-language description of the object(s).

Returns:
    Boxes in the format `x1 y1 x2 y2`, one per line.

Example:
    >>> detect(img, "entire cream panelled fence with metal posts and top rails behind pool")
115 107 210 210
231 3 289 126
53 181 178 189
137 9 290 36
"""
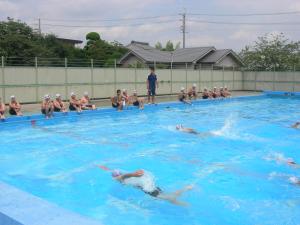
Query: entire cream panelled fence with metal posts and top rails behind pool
0 57 300 102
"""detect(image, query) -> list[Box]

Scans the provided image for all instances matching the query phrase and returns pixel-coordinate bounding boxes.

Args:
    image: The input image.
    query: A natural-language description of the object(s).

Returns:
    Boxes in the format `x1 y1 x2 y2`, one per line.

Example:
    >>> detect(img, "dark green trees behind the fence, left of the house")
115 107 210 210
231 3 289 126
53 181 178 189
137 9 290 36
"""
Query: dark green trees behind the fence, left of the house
0 18 127 66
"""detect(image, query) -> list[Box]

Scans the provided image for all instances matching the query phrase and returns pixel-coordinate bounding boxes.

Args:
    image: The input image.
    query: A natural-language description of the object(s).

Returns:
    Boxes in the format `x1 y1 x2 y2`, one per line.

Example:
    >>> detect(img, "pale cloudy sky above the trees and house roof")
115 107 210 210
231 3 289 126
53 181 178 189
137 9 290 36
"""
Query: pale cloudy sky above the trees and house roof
0 0 300 51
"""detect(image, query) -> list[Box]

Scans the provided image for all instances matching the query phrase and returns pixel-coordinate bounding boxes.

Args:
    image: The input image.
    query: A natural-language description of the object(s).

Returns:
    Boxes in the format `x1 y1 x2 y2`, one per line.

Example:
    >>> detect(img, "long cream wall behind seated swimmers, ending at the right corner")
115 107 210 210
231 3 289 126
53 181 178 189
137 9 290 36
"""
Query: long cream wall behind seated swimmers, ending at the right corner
0 67 242 103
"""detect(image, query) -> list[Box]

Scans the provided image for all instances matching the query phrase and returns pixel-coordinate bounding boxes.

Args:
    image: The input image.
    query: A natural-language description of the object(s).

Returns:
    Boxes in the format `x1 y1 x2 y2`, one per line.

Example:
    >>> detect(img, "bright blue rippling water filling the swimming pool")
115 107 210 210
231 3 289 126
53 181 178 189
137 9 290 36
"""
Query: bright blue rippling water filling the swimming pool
0 96 300 225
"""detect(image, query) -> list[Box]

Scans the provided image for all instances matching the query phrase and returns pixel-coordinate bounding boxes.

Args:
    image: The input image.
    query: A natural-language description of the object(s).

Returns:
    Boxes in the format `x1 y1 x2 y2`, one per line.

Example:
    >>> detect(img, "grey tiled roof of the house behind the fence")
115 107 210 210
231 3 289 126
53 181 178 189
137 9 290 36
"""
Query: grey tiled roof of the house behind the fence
119 41 242 64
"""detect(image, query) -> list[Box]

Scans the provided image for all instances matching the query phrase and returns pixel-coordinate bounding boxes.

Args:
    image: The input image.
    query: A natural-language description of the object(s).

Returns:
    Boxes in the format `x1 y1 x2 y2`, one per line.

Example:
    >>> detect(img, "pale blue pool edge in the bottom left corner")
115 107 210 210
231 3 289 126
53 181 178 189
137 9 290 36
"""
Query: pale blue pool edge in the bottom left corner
0 182 101 225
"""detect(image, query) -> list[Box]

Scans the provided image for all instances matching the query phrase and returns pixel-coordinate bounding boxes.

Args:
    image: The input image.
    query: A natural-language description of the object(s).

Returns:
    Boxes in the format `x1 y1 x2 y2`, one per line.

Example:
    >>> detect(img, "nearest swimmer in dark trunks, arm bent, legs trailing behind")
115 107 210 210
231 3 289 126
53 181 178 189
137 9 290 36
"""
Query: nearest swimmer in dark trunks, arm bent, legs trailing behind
112 170 193 206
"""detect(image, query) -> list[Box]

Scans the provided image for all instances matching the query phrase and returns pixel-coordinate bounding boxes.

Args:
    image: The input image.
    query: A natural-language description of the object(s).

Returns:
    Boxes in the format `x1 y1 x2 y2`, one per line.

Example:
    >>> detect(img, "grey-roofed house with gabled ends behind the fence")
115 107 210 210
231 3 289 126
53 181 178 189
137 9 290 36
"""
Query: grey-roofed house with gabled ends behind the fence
119 41 243 69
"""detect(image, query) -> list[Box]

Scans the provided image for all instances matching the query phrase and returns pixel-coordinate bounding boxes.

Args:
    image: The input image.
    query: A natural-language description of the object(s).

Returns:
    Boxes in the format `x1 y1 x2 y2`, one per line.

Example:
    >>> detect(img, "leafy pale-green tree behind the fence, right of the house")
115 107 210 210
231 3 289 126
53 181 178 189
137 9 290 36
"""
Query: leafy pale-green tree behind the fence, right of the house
240 33 300 71
